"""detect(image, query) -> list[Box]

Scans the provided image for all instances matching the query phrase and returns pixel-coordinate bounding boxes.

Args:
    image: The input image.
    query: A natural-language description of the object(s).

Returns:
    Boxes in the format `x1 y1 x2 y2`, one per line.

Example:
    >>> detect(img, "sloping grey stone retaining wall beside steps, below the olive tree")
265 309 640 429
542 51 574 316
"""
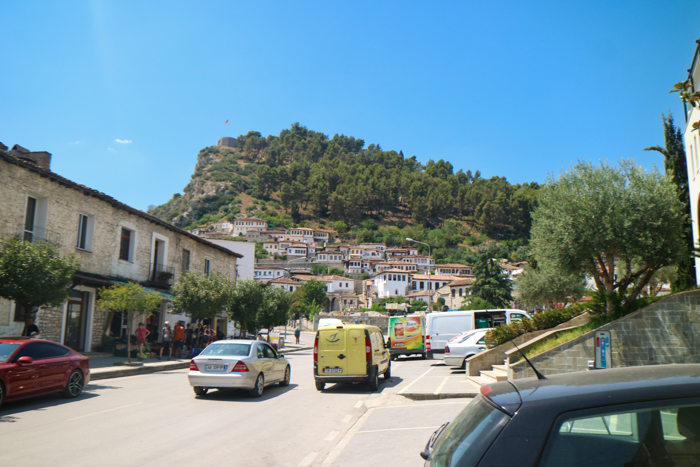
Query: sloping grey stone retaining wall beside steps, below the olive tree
508 290 700 379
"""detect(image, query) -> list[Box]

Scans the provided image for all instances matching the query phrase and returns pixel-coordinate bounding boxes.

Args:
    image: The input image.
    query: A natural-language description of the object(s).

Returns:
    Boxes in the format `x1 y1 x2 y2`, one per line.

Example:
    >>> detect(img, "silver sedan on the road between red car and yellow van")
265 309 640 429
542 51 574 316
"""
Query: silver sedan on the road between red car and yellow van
187 340 292 397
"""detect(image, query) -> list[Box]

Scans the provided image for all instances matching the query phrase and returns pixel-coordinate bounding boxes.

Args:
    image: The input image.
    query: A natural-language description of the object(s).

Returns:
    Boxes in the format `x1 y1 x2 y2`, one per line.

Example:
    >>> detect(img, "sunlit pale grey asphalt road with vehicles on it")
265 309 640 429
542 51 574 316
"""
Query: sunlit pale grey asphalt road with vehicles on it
0 351 470 467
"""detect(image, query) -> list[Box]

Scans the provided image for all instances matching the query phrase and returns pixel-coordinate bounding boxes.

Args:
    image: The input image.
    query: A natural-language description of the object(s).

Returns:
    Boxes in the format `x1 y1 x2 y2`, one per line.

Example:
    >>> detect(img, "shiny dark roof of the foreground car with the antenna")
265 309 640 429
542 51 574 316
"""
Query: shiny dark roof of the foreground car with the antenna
481 363 700 415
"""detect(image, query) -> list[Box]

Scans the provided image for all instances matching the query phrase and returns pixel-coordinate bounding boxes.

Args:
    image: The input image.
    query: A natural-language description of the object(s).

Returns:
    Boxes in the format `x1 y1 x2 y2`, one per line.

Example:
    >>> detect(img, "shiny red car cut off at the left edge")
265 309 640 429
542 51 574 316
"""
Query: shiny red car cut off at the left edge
0 338 90 406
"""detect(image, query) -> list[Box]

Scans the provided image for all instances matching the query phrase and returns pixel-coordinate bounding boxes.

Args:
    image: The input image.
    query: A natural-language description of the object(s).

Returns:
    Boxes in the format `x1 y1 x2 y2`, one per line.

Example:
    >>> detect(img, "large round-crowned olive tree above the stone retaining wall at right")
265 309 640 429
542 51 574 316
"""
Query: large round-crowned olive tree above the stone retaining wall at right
531 160 687 314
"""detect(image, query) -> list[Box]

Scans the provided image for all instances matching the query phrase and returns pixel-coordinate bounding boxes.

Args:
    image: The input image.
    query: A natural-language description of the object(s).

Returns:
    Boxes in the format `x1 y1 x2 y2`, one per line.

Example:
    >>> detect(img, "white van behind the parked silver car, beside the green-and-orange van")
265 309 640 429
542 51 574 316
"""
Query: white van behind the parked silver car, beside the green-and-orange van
425 309 530 358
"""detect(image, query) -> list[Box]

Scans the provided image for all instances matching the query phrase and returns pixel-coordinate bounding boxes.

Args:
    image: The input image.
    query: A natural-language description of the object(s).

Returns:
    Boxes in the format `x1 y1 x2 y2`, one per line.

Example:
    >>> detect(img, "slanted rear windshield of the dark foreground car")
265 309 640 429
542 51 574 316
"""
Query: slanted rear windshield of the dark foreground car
429 396 510 467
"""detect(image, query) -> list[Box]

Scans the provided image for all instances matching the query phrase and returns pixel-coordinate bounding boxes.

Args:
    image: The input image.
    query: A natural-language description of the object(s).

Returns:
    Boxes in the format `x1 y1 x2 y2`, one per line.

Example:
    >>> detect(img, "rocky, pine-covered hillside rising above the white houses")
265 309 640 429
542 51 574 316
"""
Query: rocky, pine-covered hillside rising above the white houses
150 123 539 260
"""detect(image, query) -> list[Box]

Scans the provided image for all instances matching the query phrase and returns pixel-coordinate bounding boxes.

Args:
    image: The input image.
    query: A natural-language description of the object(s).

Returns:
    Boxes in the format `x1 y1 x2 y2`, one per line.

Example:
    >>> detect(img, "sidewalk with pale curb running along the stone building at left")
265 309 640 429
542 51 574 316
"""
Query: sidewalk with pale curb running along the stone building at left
85 343 313 381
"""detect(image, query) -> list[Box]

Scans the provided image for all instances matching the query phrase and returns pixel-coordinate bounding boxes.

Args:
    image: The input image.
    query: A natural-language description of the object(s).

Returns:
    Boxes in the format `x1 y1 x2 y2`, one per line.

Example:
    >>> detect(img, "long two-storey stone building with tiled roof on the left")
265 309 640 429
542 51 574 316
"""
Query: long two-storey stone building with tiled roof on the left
0 149 241 352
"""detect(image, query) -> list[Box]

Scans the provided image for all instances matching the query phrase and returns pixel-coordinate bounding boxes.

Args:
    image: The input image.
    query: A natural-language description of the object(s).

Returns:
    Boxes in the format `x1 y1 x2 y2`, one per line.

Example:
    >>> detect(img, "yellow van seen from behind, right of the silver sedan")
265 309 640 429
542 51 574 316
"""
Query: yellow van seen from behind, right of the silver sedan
314 324 391 391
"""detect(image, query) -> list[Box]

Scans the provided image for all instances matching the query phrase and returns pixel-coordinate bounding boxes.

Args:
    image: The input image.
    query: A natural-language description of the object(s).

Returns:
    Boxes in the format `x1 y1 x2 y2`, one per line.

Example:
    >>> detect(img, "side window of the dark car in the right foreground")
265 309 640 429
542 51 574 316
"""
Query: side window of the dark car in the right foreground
539 405 700 467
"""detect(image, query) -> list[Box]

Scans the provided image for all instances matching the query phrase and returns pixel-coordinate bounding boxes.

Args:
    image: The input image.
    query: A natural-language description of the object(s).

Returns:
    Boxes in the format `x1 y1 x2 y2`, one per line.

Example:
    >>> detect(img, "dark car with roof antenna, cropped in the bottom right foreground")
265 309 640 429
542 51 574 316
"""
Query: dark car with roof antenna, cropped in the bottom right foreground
421 364 700 467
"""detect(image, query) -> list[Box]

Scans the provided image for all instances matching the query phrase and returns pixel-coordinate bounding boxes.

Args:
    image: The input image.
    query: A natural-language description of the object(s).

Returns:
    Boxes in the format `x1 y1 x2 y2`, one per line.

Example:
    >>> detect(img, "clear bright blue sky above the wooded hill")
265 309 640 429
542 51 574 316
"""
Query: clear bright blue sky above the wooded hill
0 0 700 209
